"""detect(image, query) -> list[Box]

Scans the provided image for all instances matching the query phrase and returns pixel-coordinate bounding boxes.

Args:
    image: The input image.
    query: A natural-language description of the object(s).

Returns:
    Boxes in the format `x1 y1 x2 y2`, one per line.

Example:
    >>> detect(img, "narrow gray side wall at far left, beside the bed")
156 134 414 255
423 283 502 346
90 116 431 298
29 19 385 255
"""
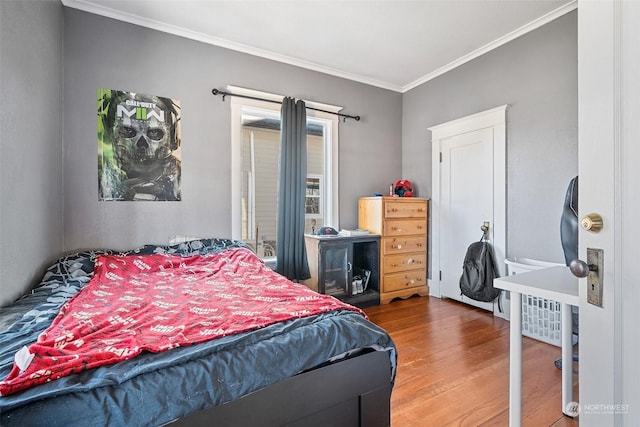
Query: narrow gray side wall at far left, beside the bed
0 0 63 305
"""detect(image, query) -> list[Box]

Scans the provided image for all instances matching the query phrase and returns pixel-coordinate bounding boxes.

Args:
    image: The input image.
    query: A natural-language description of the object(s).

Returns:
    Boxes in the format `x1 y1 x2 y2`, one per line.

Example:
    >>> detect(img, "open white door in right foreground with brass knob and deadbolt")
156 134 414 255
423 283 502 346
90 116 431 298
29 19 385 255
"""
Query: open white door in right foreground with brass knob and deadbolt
578 1 640 426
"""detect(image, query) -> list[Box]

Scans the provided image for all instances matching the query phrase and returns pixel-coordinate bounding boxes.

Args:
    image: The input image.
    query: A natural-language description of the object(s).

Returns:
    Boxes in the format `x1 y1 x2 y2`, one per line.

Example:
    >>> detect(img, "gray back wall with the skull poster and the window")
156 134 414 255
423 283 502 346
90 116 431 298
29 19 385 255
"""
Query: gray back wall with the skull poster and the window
64 8 402 254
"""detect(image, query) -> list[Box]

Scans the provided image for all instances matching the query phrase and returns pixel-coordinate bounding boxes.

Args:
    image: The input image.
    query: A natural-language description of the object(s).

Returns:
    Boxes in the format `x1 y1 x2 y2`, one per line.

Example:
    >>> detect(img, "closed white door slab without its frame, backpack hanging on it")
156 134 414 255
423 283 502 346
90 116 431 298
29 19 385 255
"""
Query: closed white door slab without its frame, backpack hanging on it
440 128 494 311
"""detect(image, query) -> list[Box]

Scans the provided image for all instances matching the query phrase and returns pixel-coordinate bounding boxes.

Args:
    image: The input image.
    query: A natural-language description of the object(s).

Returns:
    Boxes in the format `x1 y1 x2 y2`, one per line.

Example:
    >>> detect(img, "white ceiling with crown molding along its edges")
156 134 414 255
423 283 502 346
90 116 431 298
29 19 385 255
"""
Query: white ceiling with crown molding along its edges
62 0 577 92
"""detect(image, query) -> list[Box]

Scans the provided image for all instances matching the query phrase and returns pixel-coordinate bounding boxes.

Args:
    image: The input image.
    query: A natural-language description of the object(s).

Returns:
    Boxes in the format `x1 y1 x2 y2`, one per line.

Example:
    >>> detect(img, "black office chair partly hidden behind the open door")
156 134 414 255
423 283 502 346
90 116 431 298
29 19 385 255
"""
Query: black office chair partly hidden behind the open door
555 176 578 369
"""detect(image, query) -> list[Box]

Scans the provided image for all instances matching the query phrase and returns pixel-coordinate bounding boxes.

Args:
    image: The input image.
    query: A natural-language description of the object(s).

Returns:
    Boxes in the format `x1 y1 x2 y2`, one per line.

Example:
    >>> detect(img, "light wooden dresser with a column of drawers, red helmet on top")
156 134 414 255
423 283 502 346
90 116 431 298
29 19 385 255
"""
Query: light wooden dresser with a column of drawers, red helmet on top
358 197 429 304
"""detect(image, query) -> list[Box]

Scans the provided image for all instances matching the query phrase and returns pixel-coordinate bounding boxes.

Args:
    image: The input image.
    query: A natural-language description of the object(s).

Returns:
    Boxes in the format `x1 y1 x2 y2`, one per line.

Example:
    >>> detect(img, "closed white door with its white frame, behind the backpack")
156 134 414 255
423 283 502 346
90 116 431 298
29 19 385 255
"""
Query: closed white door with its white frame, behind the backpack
429 105 508 317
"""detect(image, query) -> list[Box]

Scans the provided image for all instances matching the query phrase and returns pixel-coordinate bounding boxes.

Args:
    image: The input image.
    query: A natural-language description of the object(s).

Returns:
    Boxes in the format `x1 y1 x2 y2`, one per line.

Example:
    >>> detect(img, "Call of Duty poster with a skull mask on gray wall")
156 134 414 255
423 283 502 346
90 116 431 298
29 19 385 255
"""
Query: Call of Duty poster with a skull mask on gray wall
97 89 182 201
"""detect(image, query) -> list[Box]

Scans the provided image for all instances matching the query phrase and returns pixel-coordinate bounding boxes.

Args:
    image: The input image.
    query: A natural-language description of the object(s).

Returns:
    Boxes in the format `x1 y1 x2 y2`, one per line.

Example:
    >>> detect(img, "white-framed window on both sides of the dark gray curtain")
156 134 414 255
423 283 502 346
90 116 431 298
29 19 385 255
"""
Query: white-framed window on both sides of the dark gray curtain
229 87 339 259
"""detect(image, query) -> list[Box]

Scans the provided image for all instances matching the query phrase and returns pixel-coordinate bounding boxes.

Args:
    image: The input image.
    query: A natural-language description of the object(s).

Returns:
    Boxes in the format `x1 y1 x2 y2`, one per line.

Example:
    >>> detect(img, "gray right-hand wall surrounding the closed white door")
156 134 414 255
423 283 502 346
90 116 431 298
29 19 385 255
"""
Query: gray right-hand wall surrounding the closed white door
402 11 578 263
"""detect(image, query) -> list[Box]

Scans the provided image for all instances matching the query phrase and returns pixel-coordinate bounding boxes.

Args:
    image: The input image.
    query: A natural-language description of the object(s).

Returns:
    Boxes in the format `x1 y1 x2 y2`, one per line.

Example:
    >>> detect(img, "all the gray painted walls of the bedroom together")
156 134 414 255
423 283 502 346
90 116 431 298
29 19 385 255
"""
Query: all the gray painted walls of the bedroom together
0 0 577 304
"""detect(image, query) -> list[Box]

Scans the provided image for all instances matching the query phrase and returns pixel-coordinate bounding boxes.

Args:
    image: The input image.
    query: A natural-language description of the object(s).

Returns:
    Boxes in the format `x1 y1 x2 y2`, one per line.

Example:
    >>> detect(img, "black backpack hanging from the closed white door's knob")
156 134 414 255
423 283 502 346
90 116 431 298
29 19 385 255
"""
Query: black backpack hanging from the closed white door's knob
460 241 501 303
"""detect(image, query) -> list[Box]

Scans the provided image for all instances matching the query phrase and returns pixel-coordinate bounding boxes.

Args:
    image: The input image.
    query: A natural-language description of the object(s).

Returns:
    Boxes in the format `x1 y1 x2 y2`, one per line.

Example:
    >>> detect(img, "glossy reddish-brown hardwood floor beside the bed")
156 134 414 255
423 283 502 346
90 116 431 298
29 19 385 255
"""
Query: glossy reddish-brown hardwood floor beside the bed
365 297 578 427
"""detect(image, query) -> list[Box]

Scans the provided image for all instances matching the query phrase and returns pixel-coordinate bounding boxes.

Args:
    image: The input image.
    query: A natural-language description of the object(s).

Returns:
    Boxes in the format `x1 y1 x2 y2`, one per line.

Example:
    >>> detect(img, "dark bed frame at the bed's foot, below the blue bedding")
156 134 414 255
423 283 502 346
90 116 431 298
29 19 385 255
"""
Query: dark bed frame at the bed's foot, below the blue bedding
168 351 392 427
